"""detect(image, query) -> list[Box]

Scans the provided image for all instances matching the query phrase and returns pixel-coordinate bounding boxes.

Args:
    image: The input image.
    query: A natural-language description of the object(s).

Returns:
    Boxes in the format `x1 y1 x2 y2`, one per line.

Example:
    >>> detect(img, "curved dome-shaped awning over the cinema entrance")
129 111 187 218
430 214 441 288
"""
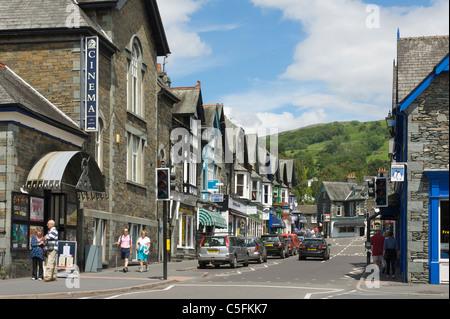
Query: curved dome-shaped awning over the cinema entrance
25 151 105 193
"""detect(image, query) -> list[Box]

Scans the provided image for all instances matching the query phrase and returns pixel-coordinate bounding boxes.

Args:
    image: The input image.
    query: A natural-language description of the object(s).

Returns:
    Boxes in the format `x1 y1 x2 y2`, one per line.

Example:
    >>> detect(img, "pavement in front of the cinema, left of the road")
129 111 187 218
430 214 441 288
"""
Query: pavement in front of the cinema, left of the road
0 260 206 300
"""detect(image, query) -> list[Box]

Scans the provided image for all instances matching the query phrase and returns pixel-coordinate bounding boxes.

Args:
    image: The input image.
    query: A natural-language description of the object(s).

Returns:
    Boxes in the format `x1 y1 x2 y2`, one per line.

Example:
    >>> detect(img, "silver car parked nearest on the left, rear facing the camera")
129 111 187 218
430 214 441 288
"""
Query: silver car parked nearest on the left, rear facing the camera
197 235 249 268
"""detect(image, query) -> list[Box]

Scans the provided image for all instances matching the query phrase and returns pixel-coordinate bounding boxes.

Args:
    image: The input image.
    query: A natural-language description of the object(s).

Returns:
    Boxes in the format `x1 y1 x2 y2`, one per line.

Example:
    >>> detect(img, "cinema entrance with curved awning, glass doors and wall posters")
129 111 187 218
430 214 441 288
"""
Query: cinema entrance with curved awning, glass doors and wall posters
10 151 106 276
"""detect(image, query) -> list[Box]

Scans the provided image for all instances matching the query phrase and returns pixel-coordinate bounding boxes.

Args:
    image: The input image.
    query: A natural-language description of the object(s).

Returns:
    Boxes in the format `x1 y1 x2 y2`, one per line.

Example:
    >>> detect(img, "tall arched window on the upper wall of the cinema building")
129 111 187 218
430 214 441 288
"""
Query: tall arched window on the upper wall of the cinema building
127 38 144 117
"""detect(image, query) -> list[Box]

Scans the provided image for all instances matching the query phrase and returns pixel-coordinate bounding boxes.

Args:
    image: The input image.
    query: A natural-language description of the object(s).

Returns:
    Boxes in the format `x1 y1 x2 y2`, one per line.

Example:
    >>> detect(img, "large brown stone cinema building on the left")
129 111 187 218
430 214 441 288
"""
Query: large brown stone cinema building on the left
0 0 171 276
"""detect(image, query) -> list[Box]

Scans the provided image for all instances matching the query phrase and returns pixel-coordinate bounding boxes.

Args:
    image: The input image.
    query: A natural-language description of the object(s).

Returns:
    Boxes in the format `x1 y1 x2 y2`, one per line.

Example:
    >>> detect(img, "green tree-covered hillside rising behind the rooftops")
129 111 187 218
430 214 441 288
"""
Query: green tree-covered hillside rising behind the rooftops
278 120 390 202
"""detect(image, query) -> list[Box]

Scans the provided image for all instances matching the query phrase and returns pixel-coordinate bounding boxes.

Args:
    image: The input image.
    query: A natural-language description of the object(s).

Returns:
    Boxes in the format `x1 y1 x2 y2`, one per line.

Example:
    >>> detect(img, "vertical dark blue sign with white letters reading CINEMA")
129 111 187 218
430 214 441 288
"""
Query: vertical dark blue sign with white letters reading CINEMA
84 37 99 132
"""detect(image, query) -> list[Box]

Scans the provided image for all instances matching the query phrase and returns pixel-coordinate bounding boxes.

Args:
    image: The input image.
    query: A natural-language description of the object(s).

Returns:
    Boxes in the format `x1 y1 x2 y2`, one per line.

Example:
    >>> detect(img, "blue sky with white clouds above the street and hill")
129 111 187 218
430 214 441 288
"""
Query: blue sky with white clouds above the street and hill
157 0 449 133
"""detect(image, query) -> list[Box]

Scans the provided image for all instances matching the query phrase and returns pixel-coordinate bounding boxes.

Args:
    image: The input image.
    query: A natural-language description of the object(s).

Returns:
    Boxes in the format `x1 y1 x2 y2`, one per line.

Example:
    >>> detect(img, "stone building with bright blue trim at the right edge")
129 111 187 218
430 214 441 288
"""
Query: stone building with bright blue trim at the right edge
389 35 449 284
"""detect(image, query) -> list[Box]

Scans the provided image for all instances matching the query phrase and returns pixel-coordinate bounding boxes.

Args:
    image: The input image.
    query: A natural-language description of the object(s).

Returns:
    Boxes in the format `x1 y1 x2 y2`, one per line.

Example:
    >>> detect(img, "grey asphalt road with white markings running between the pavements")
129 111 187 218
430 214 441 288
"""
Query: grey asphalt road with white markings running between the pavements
85 237 366 300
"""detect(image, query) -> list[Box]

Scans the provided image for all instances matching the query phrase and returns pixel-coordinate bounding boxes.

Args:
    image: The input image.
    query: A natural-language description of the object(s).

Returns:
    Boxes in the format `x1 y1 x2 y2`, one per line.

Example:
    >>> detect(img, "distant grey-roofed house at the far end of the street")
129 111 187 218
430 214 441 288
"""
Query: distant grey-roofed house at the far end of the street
317 179 368 238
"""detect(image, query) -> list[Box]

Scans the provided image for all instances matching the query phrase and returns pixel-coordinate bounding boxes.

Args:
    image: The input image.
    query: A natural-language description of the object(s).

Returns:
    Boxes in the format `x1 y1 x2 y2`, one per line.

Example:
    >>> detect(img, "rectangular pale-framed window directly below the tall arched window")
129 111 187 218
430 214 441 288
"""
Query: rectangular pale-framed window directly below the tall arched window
127 132 145 184
